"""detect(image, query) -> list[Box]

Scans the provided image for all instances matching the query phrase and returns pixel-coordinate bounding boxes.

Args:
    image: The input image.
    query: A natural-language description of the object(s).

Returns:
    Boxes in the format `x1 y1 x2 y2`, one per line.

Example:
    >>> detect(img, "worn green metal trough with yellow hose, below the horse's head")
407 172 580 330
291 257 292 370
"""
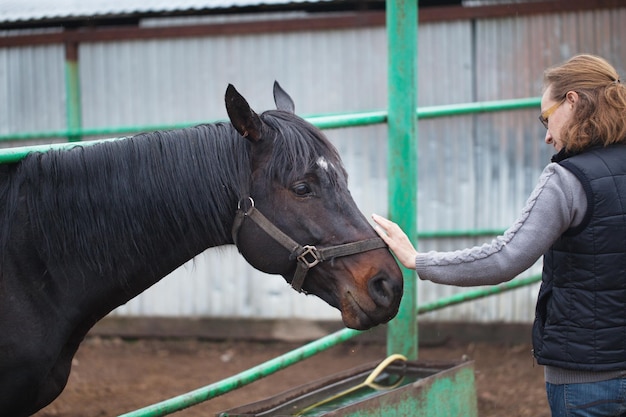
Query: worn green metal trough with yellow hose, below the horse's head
217 355 478 417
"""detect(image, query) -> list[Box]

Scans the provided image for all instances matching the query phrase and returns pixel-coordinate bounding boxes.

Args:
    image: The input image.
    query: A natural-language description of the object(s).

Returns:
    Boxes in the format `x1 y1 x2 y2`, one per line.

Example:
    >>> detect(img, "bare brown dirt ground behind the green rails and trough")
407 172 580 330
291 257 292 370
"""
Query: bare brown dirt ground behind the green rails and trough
31 337 549 417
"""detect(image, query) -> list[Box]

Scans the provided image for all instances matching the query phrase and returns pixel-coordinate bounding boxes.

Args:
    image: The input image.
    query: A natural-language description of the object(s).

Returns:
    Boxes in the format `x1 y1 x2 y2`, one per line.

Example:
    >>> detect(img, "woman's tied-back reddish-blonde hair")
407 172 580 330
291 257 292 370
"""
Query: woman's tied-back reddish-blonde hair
543 54 626 152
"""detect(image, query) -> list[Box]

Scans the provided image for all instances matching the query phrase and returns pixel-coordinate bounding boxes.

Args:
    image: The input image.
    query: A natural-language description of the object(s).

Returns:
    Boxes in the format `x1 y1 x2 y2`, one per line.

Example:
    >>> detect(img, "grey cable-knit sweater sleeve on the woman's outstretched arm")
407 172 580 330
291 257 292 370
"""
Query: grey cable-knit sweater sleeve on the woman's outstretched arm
415 163 587 287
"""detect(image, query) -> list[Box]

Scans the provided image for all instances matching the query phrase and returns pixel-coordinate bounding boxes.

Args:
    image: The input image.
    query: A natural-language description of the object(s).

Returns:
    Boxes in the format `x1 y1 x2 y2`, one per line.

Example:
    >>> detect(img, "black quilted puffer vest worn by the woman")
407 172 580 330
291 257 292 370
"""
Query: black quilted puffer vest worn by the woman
533 145 626 371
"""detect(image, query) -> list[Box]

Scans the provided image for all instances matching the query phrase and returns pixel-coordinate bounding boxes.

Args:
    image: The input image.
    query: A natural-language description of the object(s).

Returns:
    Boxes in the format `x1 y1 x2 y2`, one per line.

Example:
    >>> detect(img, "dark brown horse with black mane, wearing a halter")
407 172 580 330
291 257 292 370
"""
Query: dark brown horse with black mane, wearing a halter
0 84 402 417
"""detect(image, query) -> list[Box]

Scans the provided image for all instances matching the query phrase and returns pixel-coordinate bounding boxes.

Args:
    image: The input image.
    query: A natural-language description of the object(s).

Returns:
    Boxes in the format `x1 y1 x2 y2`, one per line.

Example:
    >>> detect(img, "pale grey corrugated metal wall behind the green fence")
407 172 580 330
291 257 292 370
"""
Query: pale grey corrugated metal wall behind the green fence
0 9 626 322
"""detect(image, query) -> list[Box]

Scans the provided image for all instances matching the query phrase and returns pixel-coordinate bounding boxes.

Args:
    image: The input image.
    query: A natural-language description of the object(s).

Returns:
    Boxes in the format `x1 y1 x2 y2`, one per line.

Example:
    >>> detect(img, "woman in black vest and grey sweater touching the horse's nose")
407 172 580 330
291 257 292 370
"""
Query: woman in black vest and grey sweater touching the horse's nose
372 55 626 417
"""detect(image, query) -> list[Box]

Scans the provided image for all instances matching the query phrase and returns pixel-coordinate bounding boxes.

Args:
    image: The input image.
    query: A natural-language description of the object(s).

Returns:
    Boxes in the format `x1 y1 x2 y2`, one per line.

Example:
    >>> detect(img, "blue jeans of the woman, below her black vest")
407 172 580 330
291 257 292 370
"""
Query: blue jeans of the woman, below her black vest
546 377 626 417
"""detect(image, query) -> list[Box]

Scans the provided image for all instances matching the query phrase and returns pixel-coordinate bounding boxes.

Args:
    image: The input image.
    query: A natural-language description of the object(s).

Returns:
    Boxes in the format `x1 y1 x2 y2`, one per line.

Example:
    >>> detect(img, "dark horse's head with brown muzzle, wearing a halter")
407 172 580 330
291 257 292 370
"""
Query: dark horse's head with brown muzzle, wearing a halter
225 83 403 329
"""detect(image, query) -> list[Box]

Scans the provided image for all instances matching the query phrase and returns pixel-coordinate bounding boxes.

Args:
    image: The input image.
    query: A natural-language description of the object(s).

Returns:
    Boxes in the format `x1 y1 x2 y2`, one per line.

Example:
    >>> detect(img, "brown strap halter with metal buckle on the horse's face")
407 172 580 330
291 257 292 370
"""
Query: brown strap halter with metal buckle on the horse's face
232 197 387 292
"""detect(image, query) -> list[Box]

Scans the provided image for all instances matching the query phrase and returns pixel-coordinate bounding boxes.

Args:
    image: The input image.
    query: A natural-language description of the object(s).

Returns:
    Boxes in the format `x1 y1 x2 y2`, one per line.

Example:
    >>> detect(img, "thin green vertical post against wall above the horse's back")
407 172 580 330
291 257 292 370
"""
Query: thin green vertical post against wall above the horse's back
65 43 83 142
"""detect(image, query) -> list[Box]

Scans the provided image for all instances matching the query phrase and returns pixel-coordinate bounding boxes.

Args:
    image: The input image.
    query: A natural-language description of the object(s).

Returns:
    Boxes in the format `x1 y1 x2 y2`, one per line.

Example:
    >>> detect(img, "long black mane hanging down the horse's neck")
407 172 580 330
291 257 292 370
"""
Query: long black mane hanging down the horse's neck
9 124 249 277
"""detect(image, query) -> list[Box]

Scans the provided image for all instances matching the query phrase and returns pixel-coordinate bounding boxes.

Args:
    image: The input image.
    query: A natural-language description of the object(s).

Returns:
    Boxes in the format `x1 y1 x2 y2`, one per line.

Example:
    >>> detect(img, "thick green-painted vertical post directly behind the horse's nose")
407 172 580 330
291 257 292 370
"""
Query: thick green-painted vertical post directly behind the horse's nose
386 0 417 360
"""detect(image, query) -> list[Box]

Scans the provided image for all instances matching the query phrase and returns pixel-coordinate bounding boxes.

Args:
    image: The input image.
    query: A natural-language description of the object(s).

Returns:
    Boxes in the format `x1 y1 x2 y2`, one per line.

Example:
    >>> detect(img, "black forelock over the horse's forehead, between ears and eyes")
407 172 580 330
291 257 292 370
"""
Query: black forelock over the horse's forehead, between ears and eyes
261 110 348 187
